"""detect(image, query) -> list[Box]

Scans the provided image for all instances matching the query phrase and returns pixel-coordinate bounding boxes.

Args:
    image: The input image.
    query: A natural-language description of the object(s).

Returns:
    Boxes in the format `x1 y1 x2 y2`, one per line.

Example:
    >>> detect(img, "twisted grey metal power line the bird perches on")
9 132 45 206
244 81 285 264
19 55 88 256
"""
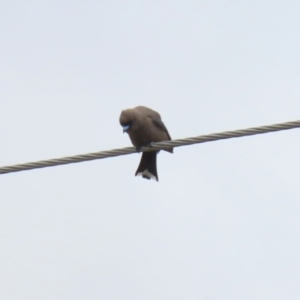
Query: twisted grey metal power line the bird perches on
0 120 300 174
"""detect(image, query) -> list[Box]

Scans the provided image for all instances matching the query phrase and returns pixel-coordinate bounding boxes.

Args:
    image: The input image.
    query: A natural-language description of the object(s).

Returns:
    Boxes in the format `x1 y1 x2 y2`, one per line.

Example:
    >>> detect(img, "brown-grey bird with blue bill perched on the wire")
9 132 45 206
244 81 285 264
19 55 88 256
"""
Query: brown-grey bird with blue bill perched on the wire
120 106 173 181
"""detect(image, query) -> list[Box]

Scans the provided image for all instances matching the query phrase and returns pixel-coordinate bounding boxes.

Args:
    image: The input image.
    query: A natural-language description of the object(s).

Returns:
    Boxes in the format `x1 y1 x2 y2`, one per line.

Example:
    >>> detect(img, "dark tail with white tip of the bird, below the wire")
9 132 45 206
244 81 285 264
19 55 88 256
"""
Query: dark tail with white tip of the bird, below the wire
135 151 158 181
